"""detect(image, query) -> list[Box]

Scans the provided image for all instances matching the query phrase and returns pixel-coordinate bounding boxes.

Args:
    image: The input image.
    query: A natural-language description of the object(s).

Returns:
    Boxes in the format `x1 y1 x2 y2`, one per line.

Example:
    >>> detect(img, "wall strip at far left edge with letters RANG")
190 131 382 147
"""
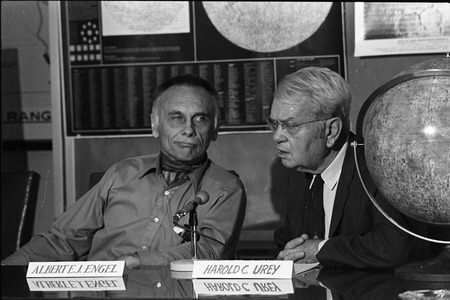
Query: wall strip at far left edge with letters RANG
1 1 54 233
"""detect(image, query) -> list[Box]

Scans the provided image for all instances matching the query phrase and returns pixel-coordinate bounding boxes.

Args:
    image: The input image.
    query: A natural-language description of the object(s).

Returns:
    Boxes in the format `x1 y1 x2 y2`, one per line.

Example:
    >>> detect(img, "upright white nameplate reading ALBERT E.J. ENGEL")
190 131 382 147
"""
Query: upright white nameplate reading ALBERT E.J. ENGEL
27 260 125 278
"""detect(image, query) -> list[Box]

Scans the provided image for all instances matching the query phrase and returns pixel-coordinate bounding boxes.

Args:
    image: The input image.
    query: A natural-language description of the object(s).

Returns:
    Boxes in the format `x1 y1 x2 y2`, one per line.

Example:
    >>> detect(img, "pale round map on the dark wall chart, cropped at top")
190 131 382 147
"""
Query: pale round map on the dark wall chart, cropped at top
203 1 332 52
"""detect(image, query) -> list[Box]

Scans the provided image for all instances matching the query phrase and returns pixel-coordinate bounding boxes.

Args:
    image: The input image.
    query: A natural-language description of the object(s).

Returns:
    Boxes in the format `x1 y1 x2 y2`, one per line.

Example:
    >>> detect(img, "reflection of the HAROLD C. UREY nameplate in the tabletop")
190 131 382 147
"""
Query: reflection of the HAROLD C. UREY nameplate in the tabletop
192 279 294 296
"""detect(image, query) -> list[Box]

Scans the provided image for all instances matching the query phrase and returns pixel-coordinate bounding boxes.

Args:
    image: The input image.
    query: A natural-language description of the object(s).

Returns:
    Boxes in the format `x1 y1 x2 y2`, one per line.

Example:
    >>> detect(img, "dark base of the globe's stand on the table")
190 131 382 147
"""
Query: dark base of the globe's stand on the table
394 245 450 283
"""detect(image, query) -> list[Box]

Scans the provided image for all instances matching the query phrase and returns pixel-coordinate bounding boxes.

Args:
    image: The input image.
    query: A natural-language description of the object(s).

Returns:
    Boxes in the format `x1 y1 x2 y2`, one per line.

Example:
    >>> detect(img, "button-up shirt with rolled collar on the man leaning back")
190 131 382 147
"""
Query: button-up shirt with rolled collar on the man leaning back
2 155 246 265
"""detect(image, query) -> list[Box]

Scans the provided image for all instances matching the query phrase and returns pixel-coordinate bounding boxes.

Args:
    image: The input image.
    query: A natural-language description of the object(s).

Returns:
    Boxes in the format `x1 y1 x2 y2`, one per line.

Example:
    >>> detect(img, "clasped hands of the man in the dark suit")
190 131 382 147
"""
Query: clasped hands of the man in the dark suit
277 234 323 263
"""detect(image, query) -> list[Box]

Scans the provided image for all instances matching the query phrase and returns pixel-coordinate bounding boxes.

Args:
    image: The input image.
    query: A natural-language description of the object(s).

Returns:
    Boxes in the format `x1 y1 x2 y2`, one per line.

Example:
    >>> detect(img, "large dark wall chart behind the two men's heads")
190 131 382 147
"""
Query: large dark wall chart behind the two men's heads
61 1 346 136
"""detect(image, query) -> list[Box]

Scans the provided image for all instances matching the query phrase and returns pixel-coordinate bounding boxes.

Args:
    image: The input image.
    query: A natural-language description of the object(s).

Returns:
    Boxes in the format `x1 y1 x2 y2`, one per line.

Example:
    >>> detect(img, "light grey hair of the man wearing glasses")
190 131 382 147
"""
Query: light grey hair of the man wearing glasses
274 67 352 134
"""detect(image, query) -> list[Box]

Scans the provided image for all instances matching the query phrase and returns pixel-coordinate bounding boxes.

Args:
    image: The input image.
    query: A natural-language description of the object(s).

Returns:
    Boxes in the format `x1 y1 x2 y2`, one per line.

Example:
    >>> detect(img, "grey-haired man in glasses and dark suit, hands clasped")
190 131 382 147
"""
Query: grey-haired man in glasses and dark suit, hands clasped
267 67 431 268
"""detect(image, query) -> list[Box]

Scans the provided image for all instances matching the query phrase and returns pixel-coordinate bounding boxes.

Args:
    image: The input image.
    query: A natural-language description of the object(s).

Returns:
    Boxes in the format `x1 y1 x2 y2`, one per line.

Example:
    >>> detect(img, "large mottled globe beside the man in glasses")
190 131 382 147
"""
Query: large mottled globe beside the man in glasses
364 58 450 224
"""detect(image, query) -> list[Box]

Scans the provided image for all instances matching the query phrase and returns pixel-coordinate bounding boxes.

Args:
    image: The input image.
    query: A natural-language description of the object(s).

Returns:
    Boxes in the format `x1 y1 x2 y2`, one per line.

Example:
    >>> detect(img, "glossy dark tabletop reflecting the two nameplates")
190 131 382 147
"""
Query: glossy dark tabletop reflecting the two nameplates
1 266 450 300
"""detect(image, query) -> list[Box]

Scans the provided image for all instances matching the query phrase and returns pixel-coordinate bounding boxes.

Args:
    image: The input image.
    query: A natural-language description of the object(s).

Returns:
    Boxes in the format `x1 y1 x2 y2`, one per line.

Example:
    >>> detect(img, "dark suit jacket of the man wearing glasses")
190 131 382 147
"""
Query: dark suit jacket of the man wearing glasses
274 136 431 268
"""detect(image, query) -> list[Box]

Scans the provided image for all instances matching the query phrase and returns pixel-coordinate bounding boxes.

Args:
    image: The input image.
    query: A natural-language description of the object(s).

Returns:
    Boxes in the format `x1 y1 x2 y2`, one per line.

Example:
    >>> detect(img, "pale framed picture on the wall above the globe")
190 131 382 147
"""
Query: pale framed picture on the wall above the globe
355 2 450 57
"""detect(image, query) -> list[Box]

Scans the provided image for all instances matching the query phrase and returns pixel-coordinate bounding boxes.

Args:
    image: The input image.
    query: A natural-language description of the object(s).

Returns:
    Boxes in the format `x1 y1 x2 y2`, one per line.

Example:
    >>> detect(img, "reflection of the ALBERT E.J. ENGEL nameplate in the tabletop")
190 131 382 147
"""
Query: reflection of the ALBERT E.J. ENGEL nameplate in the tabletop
27 277 126 291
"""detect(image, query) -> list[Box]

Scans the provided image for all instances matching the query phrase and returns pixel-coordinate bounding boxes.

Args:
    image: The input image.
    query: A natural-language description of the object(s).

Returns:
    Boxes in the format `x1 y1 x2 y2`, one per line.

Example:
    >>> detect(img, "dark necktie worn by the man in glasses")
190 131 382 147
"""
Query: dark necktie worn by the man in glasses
310 174 325 239
